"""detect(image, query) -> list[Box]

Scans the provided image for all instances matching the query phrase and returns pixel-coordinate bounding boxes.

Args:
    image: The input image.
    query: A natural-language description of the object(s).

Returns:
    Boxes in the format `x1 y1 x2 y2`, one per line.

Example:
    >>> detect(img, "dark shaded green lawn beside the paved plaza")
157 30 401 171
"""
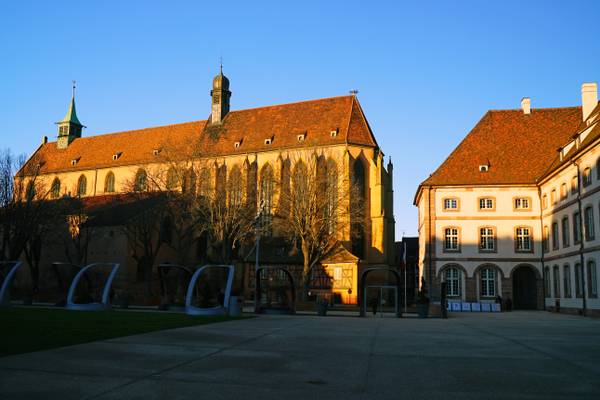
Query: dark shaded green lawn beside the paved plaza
0 307 246 357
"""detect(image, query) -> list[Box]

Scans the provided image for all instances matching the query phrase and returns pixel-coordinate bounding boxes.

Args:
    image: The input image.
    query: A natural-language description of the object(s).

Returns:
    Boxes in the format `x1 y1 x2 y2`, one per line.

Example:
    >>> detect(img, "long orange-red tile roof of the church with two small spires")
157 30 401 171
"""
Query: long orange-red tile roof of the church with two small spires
30 96 377 173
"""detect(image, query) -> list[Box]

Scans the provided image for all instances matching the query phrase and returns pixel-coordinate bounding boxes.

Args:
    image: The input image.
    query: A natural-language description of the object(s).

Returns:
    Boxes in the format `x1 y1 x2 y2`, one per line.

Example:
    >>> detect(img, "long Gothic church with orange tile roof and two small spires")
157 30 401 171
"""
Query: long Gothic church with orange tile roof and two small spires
17 72 394 302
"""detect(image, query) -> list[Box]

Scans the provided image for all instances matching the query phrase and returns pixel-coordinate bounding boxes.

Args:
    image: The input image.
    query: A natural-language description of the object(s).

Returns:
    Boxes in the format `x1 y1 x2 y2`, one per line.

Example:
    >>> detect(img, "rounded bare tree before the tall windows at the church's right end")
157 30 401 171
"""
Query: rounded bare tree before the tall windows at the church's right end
273 154 364 295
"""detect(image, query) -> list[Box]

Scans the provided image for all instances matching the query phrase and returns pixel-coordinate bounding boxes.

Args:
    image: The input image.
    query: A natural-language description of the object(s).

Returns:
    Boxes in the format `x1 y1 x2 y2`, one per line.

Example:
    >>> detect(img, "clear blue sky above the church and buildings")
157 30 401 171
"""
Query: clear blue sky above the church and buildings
0 0 600 238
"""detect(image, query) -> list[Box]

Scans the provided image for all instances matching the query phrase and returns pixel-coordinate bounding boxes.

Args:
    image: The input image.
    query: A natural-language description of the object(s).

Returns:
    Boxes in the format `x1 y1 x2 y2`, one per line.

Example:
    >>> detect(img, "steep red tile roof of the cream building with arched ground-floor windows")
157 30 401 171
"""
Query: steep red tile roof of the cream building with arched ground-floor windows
419 107 582 188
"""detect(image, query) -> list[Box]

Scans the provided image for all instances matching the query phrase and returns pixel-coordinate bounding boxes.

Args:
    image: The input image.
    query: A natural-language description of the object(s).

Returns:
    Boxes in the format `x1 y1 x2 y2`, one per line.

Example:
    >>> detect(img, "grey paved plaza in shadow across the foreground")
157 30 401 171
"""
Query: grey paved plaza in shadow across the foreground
0 312 600 400
